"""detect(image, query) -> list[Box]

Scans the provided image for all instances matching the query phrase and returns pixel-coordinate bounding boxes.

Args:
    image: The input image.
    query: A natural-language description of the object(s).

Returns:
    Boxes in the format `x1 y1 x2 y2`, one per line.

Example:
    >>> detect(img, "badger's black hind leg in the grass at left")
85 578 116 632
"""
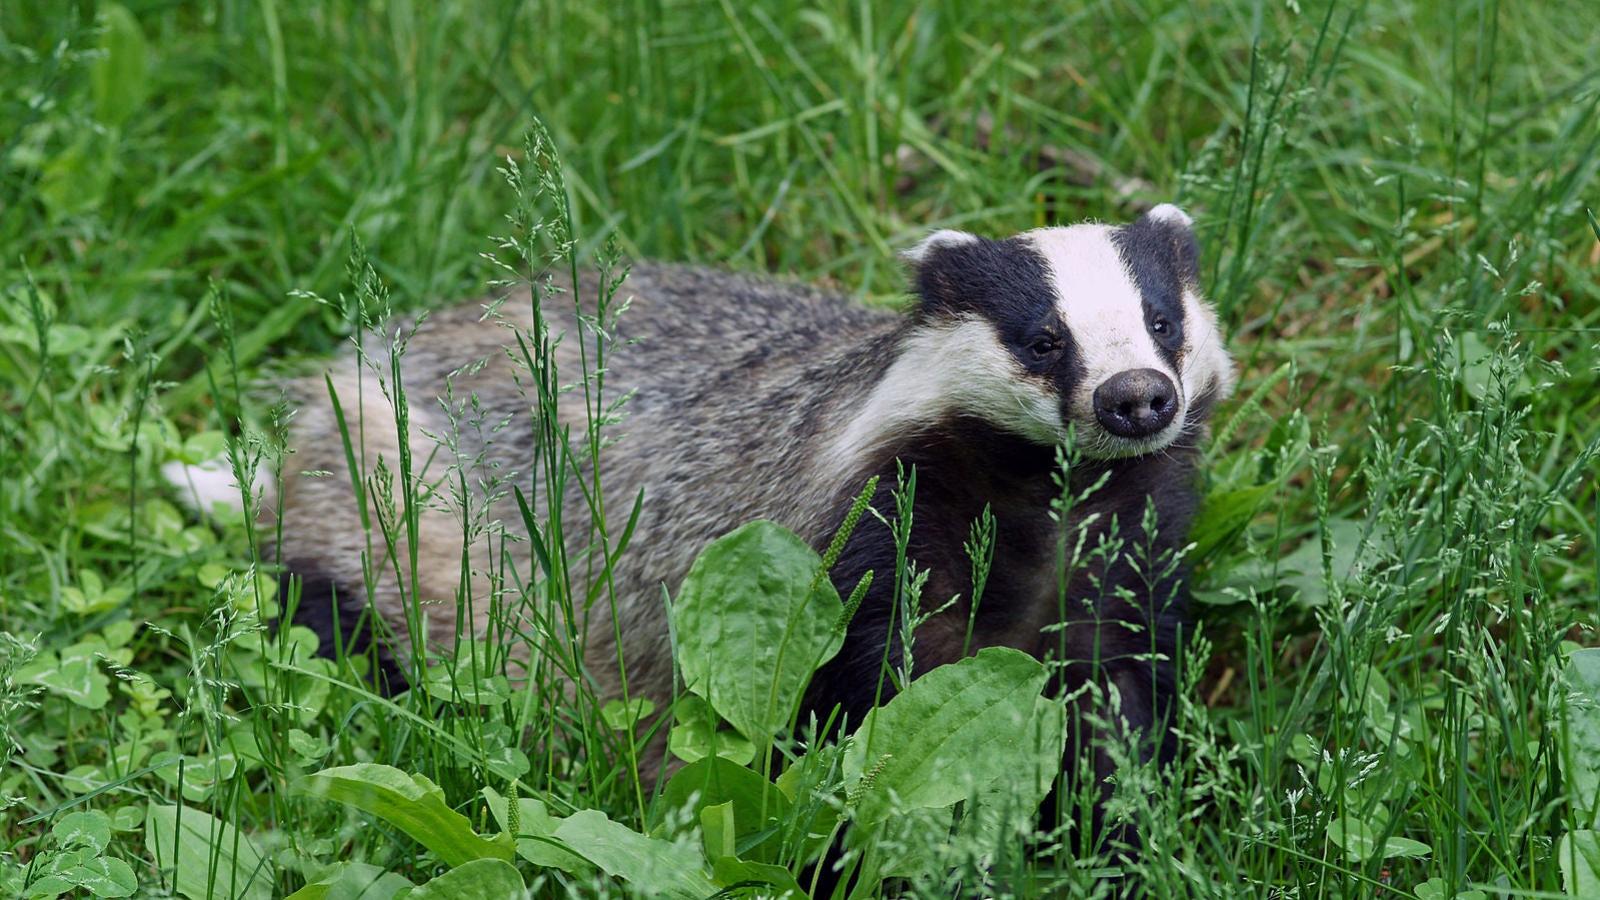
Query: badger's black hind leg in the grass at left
278 560 406 697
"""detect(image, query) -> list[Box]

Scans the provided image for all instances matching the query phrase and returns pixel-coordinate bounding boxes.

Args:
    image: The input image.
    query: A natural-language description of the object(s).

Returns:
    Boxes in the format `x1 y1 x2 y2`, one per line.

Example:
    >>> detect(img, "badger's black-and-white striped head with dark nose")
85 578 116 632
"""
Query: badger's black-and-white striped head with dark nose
888 203 1234 458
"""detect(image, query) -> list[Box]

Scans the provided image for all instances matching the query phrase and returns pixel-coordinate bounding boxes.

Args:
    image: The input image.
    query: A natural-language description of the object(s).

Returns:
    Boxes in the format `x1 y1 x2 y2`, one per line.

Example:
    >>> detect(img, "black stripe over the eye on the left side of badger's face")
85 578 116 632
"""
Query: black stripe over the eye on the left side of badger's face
915 230 1082 385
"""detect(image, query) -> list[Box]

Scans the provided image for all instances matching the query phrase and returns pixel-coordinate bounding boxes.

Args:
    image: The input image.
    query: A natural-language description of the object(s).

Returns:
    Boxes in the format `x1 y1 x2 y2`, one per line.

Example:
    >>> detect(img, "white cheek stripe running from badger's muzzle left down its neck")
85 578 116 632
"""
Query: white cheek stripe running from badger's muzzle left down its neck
824 317 1066 469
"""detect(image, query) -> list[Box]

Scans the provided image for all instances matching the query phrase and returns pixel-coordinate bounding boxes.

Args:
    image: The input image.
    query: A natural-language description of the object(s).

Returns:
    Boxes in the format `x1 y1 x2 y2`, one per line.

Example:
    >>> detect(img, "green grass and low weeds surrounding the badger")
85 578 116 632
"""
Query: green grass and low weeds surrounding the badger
0 0 1600 898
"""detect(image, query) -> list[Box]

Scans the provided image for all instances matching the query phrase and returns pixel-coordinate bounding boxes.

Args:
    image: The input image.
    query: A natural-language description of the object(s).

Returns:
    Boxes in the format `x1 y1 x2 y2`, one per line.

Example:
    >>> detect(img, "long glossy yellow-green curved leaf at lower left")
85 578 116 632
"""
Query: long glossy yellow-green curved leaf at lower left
299 762 514 866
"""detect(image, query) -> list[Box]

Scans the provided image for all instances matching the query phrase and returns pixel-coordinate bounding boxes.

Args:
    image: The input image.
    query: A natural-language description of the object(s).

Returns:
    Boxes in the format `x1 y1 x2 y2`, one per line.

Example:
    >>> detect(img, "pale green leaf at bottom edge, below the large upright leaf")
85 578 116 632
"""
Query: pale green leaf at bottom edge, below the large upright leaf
555 809 717 900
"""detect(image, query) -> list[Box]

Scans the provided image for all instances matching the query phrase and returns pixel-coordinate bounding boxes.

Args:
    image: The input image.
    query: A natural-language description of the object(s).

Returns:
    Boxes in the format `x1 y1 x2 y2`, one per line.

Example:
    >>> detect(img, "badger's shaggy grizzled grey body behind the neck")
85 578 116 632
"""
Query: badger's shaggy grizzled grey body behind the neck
280 264 901 693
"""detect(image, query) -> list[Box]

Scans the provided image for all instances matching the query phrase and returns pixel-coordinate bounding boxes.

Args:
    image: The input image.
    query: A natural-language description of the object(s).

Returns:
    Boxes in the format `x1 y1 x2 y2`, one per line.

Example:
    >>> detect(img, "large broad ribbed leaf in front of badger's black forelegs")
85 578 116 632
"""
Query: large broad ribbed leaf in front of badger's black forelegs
843 647 1046 825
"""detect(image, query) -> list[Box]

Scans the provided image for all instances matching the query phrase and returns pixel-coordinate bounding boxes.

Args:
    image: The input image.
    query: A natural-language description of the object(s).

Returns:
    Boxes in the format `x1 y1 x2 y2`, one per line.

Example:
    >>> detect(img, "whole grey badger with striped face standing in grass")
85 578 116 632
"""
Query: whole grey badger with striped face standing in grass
165 205 1234 826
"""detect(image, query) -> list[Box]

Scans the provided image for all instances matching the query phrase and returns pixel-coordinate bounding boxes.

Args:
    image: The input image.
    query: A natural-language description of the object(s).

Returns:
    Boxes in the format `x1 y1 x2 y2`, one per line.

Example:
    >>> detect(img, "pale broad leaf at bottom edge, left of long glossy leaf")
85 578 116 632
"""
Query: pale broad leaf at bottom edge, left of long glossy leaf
144 802 272 900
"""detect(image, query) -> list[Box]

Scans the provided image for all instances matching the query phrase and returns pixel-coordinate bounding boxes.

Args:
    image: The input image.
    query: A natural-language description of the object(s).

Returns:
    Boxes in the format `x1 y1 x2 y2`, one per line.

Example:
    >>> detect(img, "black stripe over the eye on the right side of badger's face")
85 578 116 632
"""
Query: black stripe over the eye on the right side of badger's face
1110 216 1200 372
